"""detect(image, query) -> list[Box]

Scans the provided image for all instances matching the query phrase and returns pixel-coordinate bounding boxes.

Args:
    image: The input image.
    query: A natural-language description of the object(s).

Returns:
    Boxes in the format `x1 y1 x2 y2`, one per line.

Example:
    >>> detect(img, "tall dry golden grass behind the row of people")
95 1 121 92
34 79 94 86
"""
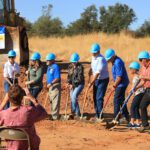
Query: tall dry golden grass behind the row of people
29 33 150 62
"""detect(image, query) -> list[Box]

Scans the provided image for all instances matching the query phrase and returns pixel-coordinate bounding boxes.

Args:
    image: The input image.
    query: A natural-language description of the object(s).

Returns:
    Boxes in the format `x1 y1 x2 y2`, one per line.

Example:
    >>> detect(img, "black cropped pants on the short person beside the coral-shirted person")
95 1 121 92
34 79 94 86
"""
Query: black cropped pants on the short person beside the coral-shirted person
130 93 144 119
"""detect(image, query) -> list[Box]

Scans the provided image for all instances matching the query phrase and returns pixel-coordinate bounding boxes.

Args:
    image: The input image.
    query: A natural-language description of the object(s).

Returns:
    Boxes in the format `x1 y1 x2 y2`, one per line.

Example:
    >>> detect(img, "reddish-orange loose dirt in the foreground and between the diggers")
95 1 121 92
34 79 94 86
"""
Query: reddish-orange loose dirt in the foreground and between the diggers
0 62 150 150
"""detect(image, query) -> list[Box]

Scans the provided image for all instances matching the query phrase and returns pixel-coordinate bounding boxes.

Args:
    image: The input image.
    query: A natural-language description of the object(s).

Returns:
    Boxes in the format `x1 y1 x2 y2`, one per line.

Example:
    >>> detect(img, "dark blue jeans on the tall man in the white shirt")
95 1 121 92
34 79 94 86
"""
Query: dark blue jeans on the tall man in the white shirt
93 78 109 118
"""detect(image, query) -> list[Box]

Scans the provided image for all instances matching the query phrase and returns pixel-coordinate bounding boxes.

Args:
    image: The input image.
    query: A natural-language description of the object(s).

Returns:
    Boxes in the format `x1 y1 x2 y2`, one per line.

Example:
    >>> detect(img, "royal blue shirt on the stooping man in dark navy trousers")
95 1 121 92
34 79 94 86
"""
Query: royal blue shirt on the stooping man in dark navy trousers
112 56 129 87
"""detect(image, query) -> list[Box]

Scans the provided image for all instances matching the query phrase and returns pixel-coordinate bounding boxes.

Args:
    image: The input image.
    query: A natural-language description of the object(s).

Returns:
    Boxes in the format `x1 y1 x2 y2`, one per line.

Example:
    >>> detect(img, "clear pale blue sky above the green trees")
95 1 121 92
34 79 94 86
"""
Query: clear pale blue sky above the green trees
15 0 150 29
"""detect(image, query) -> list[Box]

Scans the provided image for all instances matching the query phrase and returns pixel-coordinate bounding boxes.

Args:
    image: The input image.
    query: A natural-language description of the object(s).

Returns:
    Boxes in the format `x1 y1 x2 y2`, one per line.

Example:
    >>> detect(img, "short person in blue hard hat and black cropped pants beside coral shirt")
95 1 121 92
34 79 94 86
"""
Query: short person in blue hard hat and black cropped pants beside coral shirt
127 61 145 128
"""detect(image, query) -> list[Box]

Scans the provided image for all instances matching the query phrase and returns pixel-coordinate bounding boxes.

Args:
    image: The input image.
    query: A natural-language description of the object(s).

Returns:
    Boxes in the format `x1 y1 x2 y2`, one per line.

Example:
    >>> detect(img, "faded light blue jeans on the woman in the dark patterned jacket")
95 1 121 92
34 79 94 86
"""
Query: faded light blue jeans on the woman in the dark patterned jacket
70 84 84 116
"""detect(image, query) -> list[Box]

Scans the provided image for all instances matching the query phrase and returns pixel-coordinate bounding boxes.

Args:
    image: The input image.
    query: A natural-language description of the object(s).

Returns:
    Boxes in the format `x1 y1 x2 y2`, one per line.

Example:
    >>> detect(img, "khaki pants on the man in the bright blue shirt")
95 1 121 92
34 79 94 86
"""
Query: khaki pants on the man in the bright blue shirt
49 83 61 120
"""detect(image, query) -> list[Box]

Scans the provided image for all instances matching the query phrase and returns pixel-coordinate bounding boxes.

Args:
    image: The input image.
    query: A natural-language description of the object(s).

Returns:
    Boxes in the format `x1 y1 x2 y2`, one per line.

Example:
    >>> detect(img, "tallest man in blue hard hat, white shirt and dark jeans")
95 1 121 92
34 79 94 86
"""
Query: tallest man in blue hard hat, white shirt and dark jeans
89 43 109 121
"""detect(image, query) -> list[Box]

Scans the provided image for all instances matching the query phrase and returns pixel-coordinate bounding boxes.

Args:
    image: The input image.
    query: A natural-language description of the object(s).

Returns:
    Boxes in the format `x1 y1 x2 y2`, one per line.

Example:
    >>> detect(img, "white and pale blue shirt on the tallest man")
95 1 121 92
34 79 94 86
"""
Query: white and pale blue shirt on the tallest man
91 54 109 80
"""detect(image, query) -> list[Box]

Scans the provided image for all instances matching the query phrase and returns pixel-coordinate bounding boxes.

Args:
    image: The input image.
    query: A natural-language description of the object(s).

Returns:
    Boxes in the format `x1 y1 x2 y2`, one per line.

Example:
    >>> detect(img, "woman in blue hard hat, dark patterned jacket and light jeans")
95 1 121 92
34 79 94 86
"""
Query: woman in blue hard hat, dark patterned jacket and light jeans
67 53 84 118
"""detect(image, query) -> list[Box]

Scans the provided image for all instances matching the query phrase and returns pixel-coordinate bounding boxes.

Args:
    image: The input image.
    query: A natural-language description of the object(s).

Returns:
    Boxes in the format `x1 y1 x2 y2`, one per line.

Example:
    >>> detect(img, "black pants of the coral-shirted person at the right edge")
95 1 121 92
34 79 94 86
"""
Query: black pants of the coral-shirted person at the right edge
140 89 150 127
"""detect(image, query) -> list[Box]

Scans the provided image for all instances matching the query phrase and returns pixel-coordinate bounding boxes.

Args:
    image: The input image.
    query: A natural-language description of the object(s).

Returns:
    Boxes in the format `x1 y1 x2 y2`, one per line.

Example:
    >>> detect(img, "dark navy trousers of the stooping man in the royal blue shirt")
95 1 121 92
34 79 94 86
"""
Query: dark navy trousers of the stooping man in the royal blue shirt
114 86 129 120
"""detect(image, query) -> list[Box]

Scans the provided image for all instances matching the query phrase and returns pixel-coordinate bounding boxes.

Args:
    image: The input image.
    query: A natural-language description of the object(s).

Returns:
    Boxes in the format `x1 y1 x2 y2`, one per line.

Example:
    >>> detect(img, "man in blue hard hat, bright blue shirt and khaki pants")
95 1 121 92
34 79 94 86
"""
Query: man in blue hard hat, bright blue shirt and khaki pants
46 53 61 120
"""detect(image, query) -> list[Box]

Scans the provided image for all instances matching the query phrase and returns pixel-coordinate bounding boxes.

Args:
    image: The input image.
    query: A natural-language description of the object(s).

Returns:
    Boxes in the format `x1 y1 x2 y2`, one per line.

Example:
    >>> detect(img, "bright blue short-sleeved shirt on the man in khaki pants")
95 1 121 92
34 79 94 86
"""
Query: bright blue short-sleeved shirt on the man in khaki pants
46 64 60 84
